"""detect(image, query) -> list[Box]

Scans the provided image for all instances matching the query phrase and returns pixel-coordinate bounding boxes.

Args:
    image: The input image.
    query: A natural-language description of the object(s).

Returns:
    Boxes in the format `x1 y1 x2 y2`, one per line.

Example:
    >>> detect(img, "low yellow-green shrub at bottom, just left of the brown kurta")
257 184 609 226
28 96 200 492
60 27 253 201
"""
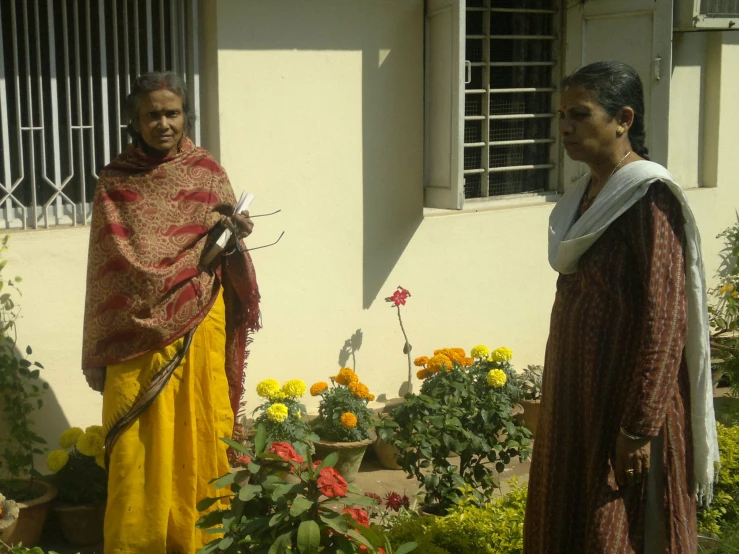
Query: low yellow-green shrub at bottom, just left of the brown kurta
388 483 527 554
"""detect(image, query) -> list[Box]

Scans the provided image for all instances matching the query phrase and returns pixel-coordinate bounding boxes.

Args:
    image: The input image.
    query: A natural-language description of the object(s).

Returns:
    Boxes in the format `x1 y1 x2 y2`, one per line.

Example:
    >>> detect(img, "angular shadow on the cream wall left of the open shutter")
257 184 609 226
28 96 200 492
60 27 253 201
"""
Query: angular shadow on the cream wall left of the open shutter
217 0 423 308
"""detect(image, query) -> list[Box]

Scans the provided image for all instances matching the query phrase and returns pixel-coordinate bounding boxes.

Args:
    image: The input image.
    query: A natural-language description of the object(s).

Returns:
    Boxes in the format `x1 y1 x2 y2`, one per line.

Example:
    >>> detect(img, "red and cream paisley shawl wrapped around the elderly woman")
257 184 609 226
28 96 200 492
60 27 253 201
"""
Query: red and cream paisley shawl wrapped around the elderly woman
82 138 260 414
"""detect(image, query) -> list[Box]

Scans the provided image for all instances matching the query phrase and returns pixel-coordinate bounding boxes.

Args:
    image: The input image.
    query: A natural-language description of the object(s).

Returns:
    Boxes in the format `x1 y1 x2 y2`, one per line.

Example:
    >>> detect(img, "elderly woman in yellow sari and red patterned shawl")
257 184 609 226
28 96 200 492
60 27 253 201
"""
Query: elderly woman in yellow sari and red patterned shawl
82 73 259 554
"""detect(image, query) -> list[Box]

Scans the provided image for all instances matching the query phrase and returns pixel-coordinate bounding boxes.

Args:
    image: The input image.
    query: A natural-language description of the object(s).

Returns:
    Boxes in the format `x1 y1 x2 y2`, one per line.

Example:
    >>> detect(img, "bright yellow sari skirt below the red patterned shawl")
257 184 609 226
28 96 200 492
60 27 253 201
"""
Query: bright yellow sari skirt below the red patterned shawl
103 295 233 554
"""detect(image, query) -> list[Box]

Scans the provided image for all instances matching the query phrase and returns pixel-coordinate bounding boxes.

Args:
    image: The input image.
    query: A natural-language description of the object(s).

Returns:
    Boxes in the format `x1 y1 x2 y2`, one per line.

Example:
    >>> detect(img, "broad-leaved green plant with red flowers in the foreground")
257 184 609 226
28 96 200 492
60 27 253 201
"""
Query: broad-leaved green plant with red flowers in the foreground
197 424 416 554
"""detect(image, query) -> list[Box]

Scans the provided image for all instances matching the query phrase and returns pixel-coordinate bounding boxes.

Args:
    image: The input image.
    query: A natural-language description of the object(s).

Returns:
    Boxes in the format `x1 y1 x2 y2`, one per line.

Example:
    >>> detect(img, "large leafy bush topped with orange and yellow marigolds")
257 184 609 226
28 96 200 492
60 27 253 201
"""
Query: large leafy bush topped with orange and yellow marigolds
379 347 530 515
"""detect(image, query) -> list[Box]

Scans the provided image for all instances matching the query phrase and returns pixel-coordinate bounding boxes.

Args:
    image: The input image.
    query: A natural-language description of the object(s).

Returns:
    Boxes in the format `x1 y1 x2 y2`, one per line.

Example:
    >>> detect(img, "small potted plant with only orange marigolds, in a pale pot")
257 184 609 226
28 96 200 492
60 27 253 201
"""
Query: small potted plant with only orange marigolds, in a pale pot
310 367 375 483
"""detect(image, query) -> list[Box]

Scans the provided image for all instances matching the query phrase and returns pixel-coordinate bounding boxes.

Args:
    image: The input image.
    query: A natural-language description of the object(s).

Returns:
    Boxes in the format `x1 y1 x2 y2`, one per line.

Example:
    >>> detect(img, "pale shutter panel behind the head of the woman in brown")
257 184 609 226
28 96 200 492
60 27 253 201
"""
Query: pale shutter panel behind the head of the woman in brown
564 0 672 186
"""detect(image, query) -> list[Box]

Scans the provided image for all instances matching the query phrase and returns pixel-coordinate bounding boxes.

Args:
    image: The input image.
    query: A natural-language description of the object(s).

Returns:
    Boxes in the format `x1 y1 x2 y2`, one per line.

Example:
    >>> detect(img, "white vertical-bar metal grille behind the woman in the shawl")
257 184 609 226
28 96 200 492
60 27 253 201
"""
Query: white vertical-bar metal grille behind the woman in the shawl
0 0 200 229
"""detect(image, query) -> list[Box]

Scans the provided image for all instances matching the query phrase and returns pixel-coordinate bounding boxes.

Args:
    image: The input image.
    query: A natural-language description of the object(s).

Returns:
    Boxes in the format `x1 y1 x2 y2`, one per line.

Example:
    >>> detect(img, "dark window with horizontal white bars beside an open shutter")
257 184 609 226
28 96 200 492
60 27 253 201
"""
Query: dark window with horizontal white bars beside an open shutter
463 0 557 198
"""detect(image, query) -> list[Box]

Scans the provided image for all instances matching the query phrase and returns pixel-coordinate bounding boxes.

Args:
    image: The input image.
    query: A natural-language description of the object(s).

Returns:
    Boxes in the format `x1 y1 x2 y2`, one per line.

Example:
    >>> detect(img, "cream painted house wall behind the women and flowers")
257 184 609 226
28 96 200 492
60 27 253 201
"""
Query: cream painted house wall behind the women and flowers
6 0 739 448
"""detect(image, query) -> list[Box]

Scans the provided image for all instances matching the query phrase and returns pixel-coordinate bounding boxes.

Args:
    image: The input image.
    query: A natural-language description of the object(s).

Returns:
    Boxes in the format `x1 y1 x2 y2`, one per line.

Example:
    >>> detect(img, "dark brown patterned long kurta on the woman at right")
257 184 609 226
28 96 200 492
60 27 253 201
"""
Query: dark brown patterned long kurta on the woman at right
524 183 697 554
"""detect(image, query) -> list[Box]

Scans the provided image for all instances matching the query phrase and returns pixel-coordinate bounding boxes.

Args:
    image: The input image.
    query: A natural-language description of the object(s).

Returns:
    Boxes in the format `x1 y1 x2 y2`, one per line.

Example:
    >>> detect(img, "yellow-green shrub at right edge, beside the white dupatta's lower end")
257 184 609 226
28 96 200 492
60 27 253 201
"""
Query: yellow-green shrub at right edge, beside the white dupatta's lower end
698 423 739 535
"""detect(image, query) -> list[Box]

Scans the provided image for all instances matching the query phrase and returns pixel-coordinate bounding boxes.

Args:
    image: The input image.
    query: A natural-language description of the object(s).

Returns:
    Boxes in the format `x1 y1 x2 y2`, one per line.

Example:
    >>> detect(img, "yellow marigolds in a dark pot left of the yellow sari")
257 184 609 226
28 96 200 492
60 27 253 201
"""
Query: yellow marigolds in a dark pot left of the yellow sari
46 425 108 546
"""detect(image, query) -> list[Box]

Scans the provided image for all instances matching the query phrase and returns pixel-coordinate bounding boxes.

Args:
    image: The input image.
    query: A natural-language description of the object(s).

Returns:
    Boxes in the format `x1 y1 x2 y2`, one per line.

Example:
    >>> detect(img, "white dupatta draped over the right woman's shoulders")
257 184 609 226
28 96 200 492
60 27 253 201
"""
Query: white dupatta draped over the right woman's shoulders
549 160 720 506
